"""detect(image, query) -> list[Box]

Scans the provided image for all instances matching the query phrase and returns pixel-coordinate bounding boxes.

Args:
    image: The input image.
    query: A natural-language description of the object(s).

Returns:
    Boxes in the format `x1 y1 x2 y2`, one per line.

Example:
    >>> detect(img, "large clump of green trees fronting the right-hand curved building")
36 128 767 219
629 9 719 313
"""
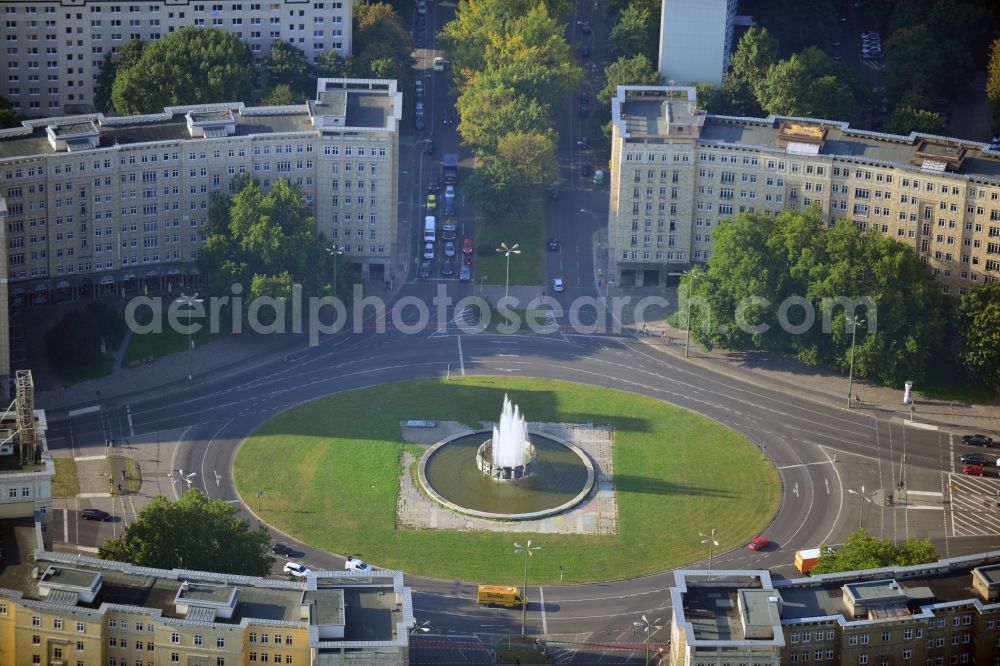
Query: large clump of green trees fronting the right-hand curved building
682 209 944 384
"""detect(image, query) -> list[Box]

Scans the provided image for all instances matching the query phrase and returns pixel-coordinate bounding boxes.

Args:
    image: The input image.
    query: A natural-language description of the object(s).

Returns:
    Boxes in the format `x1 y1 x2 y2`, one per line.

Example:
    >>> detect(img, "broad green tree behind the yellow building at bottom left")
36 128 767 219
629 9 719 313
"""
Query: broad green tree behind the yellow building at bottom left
99 488 274 576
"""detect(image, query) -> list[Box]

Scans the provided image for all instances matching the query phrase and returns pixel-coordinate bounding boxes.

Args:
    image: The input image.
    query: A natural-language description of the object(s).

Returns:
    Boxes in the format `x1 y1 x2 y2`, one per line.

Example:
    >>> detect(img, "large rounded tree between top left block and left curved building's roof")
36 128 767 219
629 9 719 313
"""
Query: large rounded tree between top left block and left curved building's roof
111 27 253 114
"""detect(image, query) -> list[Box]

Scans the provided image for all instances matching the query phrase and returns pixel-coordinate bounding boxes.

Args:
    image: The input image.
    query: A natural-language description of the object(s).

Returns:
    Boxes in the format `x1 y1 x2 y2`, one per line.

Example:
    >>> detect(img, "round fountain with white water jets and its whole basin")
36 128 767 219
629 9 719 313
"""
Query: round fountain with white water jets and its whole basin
418 395 595 520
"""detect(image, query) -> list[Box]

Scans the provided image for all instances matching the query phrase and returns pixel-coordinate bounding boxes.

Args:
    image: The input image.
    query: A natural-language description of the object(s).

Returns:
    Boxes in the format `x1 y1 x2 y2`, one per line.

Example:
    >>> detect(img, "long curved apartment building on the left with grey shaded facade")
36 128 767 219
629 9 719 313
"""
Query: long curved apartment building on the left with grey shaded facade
0 79 402 320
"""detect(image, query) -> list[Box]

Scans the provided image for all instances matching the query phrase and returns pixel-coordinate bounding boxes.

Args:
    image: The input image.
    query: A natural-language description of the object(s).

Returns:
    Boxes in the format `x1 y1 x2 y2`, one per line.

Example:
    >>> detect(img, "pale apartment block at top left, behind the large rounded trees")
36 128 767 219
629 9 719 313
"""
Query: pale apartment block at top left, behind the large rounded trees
0 0 353 117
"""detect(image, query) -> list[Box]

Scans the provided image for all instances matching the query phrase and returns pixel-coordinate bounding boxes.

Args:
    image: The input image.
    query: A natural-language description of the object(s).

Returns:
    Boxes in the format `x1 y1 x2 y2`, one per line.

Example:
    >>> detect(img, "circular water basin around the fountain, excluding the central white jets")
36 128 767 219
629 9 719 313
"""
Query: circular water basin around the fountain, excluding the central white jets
419 430 594 520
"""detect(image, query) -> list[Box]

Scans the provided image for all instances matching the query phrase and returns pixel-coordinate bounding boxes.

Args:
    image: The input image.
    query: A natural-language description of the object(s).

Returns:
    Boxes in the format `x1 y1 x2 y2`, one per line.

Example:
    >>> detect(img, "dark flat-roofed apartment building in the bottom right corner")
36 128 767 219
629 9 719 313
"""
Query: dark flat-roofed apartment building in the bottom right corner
669 551 1000 666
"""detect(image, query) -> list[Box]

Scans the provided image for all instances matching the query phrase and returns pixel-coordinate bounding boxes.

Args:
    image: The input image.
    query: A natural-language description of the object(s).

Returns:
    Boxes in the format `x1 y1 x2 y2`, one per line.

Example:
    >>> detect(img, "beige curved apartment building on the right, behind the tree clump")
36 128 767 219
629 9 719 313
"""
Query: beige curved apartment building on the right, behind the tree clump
608 86 1000 294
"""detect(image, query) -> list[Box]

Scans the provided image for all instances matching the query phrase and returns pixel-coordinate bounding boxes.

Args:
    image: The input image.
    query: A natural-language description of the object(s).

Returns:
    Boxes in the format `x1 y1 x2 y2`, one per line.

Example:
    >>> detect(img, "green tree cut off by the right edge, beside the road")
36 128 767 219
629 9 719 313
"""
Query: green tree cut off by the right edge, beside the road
958 282 1000 391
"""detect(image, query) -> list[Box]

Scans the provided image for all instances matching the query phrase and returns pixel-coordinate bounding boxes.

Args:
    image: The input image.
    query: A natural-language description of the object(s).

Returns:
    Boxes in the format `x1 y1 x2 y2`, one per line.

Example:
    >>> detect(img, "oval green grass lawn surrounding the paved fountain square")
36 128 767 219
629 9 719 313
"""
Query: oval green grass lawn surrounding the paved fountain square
234 377 780 584
